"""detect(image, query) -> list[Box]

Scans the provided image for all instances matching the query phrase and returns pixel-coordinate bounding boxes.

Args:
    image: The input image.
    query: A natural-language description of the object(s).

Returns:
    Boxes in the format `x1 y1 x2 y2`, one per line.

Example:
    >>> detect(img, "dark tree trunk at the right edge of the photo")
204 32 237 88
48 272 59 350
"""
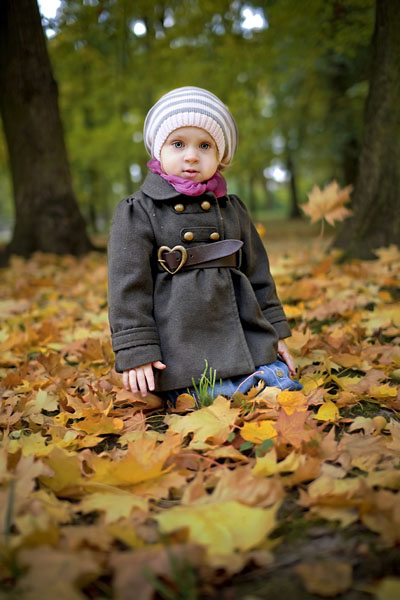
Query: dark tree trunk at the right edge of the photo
334 0 400 258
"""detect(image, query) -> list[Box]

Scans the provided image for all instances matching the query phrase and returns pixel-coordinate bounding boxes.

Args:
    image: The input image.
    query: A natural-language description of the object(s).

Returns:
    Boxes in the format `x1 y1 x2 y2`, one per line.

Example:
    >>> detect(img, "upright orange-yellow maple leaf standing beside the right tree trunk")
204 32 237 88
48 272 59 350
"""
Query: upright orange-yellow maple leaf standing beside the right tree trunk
301 181 353 225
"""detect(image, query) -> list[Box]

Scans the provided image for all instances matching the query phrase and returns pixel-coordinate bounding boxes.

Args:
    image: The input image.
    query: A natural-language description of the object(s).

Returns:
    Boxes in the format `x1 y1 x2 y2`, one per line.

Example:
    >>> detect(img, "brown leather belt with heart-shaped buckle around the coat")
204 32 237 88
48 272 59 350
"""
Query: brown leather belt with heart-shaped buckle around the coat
158 240 243 275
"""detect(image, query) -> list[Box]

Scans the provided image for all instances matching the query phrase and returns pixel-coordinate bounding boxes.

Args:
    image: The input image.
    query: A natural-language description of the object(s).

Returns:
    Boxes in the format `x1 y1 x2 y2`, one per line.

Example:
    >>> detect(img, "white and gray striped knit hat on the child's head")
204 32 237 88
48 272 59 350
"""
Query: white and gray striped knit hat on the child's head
143 87 238 166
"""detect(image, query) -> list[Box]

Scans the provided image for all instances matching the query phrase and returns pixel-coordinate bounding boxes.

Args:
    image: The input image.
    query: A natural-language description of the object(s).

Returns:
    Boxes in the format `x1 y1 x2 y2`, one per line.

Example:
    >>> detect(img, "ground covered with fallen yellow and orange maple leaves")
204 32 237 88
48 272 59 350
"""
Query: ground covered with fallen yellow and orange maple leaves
0 231 400 600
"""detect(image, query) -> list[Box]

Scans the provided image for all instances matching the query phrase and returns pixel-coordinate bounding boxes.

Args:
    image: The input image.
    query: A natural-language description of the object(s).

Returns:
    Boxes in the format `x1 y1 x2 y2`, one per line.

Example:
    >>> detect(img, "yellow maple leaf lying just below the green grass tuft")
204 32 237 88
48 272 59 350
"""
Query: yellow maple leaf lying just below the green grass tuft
164 396 240 445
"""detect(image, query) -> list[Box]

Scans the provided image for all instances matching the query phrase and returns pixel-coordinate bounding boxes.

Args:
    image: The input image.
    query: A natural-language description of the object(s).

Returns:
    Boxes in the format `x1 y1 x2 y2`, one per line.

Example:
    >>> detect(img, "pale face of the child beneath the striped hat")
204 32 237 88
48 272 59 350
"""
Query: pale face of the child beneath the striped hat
160 127 219 182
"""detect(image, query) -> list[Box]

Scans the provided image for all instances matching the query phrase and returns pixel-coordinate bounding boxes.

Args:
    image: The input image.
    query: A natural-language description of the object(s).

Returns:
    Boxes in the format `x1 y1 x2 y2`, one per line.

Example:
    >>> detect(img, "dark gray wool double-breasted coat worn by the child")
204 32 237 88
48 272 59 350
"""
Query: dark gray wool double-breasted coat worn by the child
108 173 290 391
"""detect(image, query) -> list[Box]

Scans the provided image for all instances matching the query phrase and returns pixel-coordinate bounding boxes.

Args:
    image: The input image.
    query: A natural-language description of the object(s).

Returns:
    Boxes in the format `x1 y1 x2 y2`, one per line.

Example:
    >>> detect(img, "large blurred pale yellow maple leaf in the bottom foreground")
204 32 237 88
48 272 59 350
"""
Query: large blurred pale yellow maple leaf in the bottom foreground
155 500 280 555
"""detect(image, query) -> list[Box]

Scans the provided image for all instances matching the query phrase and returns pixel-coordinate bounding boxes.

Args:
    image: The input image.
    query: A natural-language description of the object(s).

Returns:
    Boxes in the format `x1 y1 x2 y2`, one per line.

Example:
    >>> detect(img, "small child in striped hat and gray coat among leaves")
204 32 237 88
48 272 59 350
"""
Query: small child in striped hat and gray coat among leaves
108 87 302 402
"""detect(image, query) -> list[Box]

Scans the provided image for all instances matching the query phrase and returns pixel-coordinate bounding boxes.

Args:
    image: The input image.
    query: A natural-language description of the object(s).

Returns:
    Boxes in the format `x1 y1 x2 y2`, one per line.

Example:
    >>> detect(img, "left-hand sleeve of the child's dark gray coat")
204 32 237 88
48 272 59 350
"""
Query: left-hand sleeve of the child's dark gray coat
108 197 161 373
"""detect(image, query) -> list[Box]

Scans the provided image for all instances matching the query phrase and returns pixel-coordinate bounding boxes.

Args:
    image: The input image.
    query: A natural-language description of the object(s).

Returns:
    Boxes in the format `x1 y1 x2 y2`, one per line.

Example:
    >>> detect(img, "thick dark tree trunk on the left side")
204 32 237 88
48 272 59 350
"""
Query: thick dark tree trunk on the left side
0 0 92 256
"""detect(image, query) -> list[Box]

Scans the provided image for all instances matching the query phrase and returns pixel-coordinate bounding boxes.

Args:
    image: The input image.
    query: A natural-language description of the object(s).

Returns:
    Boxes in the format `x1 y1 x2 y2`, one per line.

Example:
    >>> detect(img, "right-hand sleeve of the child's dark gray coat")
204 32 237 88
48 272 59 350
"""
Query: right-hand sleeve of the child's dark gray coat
231 196 291 339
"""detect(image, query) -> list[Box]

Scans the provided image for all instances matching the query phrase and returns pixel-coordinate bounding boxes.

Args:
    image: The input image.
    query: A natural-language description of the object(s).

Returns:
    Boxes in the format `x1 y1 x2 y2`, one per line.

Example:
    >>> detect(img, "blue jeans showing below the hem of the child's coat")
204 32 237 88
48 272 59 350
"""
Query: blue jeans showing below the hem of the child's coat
163 358 303 406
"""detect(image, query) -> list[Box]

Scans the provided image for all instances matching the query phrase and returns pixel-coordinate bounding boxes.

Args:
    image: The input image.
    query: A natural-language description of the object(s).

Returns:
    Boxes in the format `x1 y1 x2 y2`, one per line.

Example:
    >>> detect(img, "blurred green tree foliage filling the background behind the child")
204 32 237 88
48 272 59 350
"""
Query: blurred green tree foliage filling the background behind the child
0 0 374 234
